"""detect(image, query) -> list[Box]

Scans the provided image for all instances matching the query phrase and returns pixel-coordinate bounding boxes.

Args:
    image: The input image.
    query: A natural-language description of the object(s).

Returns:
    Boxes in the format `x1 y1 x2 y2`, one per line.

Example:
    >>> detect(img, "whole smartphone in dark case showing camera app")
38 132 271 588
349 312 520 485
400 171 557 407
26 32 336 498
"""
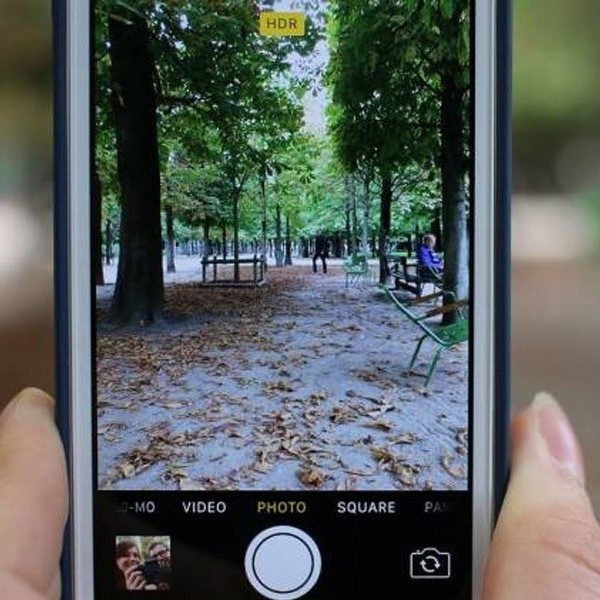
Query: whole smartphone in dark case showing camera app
54 0 510 600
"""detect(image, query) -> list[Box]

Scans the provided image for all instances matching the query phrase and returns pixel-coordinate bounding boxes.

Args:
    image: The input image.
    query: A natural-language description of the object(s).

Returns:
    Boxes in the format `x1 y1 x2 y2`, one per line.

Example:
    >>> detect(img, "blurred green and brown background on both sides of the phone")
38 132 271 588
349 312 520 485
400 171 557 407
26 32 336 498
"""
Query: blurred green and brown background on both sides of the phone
0 0 600 514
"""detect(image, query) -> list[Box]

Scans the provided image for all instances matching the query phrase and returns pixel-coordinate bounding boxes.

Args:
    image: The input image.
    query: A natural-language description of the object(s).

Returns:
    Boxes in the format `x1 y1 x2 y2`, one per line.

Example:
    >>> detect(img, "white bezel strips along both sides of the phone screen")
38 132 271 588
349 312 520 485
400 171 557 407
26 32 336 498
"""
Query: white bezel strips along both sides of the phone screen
64 0 496 600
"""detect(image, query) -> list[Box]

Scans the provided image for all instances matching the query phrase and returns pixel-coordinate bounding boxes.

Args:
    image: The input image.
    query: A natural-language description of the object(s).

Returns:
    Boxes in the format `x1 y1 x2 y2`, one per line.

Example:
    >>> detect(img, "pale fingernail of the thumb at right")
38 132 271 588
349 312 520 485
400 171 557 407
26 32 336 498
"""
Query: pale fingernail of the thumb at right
533 392 585 483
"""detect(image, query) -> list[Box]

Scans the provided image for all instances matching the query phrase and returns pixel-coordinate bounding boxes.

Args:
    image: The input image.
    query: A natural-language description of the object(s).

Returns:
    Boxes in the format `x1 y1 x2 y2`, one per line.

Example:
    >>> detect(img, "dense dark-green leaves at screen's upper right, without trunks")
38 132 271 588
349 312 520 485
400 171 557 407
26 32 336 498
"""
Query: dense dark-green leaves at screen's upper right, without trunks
329 0 470 183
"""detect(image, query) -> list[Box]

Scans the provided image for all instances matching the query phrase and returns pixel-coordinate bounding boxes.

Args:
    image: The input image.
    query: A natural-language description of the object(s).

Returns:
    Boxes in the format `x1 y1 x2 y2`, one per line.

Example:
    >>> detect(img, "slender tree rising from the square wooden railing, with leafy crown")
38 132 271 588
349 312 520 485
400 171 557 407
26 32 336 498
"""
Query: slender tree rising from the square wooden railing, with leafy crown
152 0 316 281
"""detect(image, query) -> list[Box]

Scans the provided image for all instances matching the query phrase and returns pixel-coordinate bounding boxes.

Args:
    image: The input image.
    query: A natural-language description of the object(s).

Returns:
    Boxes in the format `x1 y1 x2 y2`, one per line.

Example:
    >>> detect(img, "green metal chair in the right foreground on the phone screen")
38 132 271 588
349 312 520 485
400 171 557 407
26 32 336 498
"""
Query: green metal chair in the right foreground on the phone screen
381 286 469 387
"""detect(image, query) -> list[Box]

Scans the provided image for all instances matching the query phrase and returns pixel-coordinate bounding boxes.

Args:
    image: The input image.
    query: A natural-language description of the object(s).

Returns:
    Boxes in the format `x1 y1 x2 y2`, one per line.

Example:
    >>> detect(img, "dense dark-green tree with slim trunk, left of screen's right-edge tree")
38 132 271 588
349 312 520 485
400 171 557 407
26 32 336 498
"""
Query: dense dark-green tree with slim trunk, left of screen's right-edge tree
329 0 435 283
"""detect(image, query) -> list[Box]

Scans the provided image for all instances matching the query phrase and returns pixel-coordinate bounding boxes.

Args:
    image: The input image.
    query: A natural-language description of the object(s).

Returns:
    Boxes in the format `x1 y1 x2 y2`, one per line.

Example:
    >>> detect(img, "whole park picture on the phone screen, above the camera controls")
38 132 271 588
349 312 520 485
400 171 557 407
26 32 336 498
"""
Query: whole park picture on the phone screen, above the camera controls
90 0 472 491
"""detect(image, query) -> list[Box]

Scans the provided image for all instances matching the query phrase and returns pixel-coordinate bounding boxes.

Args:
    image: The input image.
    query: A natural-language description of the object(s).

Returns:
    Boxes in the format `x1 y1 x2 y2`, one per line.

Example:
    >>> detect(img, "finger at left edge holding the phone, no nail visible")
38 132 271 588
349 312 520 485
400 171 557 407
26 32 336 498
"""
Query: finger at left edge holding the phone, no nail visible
0 389 68 600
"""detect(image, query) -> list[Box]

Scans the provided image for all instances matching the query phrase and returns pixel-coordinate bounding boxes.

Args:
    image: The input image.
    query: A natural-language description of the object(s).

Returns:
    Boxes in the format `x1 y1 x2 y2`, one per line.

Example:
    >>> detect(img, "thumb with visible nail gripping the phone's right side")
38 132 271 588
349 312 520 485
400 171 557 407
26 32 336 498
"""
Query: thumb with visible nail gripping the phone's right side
484 393 600 600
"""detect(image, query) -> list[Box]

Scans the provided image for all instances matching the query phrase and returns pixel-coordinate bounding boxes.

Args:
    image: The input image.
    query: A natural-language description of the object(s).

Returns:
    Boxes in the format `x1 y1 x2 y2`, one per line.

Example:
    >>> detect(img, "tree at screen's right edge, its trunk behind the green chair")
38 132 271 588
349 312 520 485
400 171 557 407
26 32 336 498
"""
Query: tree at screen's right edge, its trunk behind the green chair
396 0 471 322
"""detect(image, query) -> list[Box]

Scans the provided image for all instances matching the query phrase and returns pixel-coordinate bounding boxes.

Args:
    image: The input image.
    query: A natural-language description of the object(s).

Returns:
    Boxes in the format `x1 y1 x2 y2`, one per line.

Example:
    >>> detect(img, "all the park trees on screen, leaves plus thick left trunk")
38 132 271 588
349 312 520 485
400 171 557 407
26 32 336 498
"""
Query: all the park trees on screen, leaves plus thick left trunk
95 0 470 322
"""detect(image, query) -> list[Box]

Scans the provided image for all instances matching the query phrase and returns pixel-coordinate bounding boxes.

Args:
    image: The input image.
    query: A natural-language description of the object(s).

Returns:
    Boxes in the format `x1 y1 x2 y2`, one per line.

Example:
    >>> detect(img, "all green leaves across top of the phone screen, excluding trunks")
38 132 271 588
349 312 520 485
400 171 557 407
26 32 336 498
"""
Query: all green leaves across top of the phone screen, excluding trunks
95 0 469 268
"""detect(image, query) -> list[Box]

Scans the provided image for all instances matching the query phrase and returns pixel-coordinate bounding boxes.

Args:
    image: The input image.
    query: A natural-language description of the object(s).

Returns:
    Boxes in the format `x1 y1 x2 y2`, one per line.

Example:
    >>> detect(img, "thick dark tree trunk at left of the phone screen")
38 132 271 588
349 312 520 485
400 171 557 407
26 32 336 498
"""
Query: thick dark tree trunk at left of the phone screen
109 11 164 323
